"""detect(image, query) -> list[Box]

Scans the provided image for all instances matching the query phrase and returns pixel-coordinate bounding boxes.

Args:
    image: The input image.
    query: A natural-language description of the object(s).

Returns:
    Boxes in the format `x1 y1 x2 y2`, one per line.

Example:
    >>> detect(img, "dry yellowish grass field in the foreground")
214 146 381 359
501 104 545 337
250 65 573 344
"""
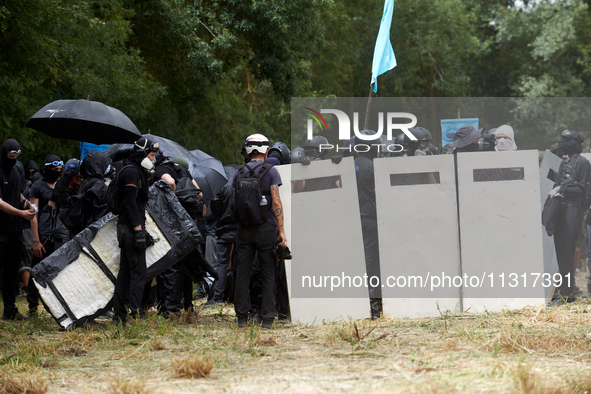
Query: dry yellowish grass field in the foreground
0 286 591 393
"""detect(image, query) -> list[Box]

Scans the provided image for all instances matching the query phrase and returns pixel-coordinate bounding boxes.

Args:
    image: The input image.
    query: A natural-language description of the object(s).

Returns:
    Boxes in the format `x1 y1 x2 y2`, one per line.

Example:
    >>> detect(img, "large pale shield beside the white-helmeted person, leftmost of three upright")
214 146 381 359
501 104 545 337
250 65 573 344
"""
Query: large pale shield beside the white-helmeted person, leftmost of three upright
280 158 369 324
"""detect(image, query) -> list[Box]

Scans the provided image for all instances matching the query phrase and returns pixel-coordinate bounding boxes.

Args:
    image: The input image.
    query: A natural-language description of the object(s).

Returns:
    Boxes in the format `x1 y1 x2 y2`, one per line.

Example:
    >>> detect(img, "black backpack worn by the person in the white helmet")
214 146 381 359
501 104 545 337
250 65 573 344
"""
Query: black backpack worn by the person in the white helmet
234 163 272 226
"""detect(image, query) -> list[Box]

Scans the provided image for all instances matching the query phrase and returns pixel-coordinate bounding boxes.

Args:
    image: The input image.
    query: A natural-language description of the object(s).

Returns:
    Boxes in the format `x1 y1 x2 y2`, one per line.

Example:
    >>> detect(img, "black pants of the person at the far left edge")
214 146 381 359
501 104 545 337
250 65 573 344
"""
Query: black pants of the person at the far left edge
0 230 23 317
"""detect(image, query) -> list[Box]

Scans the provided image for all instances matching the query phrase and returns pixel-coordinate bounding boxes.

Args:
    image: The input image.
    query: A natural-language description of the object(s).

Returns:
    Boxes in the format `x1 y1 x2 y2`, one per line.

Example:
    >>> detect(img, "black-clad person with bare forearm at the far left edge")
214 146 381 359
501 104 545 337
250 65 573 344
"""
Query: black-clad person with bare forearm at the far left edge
0 139 36 320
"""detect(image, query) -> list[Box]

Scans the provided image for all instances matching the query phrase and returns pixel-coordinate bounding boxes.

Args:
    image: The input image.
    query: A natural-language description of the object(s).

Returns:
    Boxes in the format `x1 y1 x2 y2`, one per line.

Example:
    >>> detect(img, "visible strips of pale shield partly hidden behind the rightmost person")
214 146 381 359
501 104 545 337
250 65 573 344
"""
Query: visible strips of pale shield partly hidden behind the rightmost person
540 150 562 299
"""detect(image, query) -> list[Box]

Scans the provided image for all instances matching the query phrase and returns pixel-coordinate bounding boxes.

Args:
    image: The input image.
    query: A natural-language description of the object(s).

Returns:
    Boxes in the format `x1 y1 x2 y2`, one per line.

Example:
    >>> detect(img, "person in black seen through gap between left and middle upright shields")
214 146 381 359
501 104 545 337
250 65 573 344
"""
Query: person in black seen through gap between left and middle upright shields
355 130 382 319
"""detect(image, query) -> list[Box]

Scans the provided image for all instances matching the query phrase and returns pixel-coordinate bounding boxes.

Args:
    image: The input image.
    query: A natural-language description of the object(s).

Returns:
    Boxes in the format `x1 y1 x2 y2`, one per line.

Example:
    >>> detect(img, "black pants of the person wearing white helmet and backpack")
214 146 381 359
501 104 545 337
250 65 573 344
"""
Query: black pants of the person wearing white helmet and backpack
234 222 277 320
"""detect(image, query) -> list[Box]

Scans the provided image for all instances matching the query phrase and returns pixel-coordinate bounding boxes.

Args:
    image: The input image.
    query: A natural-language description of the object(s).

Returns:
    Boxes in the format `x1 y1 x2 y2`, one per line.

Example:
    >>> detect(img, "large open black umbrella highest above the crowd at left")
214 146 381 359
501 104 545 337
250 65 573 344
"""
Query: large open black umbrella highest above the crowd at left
25 100 142 145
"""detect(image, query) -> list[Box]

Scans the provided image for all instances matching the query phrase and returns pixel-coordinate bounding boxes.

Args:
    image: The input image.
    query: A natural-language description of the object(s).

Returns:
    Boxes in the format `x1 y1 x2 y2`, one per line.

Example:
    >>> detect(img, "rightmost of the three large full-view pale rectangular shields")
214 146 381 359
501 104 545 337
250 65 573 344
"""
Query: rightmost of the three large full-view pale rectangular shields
456 151 551 311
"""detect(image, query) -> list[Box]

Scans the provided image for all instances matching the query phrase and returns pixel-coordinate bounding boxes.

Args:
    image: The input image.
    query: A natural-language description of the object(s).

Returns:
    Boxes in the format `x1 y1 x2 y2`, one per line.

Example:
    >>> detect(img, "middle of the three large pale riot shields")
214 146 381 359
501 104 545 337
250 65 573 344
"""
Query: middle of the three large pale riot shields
374 155 460 317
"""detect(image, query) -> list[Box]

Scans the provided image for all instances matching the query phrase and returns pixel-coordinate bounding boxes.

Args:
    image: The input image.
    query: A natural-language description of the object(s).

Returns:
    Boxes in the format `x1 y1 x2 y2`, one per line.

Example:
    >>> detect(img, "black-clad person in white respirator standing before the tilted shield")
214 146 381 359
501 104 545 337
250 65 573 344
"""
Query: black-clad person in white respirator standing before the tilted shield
113 138 159 323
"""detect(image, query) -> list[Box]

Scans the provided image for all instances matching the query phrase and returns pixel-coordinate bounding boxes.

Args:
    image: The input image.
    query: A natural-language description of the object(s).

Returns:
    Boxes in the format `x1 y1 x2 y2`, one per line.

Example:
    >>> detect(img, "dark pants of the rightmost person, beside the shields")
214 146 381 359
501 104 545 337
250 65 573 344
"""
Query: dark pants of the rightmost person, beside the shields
554 205 583 297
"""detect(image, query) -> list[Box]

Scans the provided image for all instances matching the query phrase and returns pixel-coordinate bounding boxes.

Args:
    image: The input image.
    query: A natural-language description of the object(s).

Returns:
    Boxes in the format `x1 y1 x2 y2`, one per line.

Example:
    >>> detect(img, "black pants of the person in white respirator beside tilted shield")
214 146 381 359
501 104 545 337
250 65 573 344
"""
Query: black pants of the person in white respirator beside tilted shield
113 225 147 321
